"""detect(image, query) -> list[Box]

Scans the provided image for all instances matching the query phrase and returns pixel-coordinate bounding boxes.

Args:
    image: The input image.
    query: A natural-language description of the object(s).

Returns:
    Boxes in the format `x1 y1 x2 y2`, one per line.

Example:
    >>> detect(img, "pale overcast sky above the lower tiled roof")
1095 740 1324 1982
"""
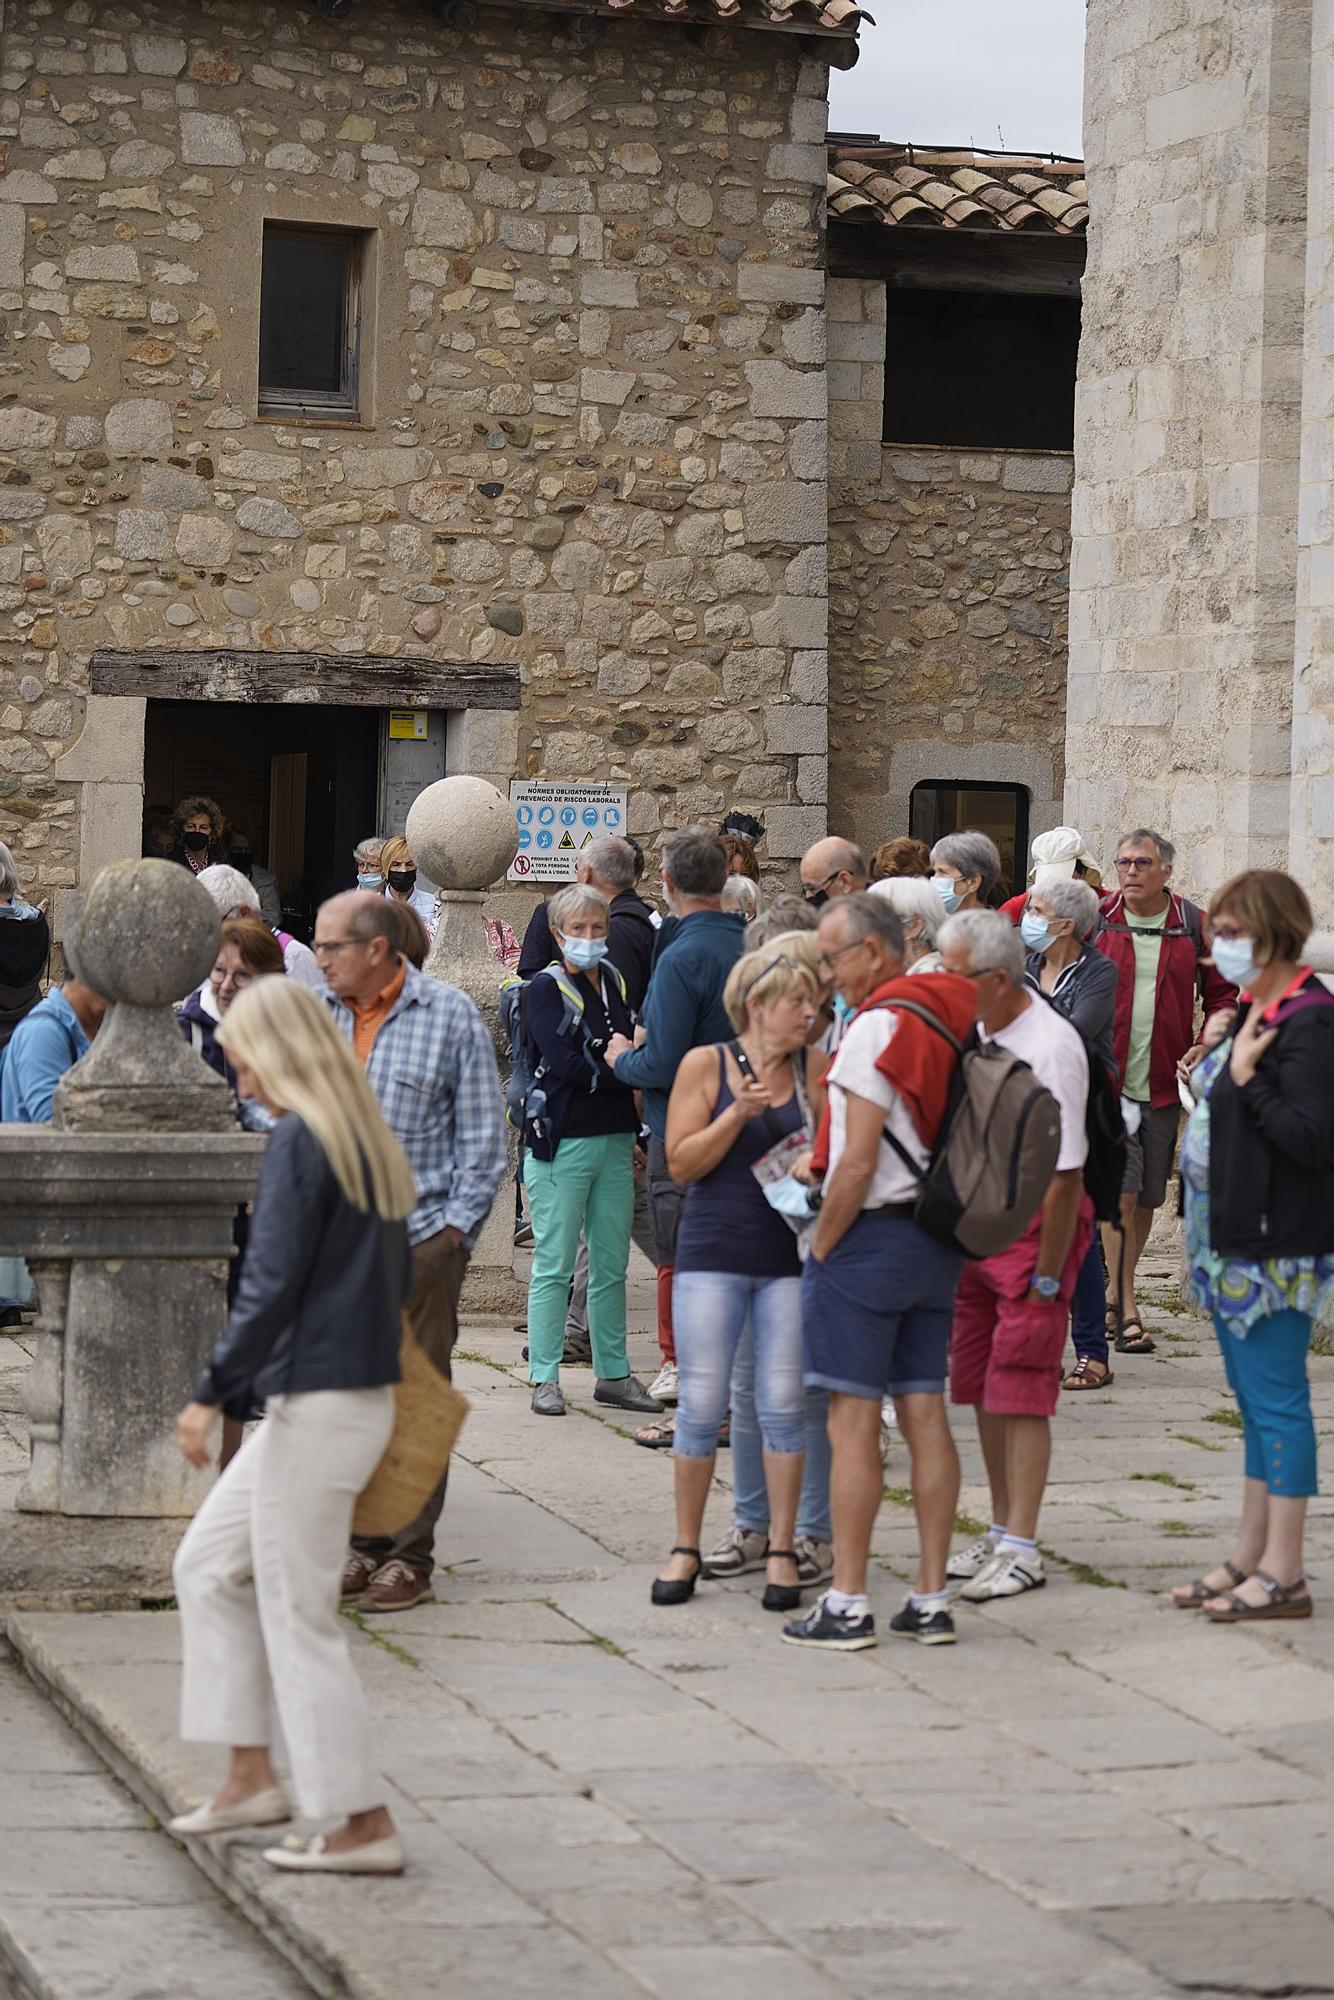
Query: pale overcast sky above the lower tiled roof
830 0 1084 154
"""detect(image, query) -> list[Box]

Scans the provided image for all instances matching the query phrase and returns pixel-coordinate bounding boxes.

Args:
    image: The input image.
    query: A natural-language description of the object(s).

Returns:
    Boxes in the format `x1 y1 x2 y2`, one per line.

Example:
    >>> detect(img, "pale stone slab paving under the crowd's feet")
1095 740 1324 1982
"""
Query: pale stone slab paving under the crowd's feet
0 1264 1334 2000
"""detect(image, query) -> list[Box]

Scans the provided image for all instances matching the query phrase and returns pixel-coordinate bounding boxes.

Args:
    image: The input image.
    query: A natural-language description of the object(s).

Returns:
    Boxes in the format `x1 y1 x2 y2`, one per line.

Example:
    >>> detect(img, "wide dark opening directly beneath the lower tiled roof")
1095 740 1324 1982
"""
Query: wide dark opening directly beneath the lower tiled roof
884 286 1080 452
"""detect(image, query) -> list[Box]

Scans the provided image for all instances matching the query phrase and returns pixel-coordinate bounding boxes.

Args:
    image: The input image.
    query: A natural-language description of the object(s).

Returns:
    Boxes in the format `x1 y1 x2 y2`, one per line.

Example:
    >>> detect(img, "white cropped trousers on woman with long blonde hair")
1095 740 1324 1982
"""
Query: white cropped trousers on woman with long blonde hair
172 1388 394 1820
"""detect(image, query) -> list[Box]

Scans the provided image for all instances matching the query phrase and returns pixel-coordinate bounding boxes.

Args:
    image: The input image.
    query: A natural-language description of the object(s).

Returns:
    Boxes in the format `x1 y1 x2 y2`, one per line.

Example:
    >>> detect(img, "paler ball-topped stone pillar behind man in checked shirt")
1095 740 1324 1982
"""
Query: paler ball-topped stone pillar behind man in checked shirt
408 776 526 1314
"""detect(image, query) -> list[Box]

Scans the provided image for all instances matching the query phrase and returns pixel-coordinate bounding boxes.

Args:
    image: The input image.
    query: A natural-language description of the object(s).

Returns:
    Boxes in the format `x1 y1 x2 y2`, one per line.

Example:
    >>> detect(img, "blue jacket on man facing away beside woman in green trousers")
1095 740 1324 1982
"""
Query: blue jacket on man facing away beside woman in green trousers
616 910 746 1138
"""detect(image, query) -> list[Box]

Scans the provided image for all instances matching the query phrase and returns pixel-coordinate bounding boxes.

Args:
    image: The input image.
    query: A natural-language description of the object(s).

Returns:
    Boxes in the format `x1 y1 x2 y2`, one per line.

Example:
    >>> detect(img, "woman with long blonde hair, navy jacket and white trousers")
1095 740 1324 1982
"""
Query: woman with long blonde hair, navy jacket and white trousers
172 980 416 1874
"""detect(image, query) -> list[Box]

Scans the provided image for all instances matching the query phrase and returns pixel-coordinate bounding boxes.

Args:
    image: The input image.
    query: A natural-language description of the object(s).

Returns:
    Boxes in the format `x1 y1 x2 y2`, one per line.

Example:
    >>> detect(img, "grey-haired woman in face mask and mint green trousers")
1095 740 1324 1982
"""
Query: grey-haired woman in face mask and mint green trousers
520 882 662 1416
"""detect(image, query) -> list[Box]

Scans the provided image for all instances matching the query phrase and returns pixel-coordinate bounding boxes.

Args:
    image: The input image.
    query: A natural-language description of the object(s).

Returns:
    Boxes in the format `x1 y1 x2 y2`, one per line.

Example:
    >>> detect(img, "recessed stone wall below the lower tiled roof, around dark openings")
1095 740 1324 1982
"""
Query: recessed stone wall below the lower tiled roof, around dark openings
828 278 1072 850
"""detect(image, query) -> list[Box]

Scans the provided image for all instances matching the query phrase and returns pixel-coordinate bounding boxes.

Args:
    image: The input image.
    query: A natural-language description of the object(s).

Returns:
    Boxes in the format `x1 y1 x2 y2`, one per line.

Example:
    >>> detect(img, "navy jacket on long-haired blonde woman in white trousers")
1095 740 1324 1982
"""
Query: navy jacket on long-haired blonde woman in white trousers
194 1112 410 1406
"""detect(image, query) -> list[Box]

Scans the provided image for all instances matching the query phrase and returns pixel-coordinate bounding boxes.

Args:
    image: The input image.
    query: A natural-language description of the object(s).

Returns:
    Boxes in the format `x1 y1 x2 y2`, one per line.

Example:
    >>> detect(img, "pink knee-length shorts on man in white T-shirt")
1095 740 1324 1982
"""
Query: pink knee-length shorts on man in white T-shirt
950 1196 1094 1416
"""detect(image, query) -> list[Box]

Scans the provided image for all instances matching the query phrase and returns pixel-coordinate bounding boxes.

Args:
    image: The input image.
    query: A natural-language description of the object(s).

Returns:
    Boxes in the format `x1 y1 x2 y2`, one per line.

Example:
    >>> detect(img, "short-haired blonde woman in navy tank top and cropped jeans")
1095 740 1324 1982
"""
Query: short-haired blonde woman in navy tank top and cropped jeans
652 932 820 1610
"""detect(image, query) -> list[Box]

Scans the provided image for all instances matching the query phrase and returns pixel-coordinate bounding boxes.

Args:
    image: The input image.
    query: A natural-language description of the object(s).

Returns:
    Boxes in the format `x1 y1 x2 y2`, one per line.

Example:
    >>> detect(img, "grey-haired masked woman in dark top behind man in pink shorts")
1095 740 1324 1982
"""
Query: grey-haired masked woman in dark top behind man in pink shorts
1020 876 1116 1394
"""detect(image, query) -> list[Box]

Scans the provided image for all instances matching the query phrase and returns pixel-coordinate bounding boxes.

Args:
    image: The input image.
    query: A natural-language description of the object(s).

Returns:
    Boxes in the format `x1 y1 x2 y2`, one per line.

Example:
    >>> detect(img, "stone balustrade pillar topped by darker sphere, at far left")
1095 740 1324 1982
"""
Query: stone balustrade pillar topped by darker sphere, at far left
0 860 264 1516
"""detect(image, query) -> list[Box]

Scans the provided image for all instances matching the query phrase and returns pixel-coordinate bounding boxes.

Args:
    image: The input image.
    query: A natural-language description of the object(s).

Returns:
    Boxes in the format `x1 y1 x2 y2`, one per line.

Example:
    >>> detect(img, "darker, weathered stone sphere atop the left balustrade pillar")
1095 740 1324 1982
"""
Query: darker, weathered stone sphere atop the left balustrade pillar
66 860 222 1006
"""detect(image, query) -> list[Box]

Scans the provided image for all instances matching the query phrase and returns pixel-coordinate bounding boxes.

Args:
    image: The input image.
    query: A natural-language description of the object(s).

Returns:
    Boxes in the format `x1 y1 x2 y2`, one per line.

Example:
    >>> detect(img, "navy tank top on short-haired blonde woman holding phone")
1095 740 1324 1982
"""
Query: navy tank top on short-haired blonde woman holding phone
676 1044 802 1278
